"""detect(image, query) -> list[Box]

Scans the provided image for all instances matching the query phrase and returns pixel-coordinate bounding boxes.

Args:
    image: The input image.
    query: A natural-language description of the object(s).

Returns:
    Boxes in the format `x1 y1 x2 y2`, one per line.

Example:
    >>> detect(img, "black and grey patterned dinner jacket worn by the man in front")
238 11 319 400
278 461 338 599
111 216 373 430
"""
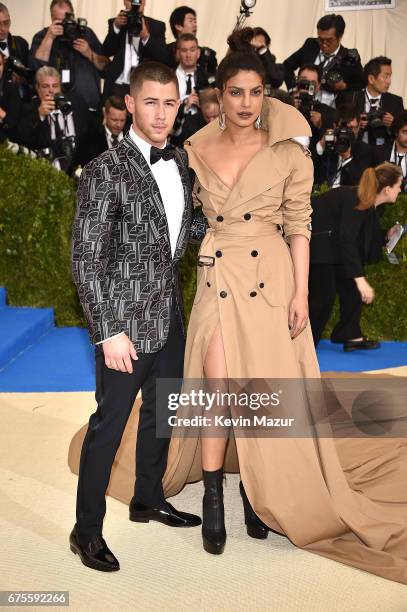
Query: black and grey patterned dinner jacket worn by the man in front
72 134 205 353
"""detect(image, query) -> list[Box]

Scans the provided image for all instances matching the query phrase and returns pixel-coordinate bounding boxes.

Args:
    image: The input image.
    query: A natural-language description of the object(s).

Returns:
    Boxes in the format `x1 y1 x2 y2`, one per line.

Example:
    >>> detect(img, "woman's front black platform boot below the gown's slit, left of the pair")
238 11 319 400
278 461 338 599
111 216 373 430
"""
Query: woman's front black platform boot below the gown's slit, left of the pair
202 468 226 555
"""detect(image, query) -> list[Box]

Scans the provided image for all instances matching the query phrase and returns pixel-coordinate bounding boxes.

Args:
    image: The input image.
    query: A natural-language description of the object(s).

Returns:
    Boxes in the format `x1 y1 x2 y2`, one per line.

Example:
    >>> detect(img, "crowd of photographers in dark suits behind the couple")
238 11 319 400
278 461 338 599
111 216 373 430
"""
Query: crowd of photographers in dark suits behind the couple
0 0 407 188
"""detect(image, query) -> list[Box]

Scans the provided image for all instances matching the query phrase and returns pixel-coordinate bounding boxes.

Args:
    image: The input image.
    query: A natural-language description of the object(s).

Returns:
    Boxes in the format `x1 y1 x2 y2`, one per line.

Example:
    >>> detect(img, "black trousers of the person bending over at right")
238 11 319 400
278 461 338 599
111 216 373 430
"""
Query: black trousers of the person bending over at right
308 264 363 346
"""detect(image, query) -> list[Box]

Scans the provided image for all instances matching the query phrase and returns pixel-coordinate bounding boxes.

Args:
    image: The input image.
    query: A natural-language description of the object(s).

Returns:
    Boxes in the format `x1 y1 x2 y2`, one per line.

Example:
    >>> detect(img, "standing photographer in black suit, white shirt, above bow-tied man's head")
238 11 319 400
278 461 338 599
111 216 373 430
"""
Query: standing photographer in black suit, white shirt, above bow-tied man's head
103 0 170 100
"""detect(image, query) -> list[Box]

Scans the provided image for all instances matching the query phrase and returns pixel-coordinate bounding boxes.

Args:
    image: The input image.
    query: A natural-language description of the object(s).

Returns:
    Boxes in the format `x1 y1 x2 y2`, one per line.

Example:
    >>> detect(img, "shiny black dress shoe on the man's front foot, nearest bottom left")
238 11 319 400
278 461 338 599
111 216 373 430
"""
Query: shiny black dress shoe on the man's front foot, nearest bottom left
69 525 120 572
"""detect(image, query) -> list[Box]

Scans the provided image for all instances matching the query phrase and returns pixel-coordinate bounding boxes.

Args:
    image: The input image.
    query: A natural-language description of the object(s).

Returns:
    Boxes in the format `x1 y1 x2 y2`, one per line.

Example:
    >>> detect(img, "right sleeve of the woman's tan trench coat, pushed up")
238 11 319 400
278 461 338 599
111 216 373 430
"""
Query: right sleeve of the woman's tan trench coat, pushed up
281 143 314 242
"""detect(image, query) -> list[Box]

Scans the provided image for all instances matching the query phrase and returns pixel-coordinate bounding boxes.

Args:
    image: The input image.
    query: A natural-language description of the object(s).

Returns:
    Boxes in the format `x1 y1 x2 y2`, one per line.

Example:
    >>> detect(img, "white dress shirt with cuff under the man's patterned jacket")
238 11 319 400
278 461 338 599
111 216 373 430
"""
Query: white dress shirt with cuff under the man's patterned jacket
97 127 185 344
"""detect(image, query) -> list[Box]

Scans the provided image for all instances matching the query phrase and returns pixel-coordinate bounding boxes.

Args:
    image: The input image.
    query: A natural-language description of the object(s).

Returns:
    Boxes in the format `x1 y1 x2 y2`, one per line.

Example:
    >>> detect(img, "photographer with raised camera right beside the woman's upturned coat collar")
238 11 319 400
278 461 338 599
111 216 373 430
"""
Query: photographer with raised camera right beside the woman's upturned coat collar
292 64 335 137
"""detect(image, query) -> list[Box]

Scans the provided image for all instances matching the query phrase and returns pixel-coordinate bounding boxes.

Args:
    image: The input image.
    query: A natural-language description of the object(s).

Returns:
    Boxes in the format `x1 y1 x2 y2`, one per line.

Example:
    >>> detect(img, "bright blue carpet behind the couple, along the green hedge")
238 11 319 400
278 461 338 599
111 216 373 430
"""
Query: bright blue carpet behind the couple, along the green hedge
0 327 407 392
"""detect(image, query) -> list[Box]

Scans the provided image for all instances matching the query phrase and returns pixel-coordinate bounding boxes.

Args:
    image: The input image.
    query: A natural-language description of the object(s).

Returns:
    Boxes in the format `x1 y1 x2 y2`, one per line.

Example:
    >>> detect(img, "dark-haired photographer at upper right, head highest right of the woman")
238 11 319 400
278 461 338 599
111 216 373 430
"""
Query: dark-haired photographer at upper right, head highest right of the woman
284 14 364 107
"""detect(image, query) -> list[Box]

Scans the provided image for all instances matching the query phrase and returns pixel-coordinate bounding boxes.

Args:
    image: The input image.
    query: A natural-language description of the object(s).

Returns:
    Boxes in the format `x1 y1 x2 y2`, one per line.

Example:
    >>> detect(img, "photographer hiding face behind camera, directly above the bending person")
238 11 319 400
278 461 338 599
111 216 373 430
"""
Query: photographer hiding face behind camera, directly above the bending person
314 107 378 187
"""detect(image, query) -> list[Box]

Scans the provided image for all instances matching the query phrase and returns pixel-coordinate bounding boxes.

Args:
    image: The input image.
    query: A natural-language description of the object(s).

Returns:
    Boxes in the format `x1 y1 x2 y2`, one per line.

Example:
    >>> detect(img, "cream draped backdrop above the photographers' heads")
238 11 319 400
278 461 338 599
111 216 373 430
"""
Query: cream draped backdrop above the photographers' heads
3 0 407 104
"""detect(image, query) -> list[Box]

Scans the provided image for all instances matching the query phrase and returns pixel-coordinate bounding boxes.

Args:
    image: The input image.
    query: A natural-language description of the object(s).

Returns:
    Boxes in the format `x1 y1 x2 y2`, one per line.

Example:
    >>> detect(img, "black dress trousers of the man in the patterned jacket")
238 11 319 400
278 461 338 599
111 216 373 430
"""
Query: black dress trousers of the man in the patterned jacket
76 295 185 536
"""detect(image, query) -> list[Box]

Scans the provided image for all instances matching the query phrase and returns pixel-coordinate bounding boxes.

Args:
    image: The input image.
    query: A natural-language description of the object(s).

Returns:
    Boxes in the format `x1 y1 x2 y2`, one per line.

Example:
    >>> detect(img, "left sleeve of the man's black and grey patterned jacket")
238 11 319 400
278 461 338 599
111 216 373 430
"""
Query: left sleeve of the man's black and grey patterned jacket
71 161 124 344
